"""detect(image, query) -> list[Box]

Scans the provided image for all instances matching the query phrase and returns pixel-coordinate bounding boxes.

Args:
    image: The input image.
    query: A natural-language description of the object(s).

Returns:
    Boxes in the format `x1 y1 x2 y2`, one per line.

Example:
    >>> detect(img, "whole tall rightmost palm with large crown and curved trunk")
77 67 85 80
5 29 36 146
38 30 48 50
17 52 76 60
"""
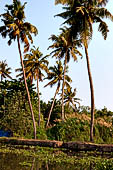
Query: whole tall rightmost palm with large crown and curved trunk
57 0 113 141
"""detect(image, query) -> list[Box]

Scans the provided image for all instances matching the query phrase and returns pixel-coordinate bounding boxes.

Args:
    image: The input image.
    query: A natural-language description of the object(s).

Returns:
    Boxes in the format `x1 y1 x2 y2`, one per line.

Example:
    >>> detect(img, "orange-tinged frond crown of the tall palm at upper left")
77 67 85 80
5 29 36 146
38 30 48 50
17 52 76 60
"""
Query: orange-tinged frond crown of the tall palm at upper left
0 0 37 52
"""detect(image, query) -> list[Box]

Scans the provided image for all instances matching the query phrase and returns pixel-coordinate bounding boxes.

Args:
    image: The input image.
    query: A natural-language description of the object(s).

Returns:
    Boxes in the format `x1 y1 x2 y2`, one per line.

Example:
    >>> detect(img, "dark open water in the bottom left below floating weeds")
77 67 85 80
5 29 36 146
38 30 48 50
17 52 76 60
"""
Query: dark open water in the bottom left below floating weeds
0 153 76 170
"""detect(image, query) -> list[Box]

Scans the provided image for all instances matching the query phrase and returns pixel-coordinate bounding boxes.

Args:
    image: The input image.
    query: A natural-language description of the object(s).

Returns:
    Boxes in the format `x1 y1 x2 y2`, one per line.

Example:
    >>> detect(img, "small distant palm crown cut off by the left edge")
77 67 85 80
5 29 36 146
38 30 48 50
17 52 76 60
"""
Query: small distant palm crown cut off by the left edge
0 60 12 81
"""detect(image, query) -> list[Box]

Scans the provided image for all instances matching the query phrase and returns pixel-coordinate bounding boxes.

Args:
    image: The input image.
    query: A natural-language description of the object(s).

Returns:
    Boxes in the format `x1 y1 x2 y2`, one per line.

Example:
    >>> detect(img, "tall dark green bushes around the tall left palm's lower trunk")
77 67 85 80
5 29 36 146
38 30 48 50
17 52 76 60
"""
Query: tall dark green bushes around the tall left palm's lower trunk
0 80 46 139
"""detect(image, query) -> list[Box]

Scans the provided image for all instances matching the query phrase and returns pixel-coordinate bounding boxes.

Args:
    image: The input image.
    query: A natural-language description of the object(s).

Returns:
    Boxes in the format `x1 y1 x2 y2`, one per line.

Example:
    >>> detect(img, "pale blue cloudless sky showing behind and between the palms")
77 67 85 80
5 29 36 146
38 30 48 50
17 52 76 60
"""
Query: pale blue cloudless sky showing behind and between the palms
0 0 113 111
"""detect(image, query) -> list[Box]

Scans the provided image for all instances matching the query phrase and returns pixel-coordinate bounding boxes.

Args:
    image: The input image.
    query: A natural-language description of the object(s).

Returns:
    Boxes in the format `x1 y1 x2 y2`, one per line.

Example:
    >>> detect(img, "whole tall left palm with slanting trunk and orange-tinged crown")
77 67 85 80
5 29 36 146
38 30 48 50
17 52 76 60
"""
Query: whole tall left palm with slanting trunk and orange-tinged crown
0 0 37 139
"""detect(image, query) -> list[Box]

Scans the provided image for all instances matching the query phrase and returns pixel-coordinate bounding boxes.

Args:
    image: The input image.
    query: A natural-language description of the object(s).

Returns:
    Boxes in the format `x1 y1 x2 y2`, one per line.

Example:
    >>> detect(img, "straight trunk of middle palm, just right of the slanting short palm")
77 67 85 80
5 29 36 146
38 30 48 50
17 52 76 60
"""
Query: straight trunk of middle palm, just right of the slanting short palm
62 55 67 121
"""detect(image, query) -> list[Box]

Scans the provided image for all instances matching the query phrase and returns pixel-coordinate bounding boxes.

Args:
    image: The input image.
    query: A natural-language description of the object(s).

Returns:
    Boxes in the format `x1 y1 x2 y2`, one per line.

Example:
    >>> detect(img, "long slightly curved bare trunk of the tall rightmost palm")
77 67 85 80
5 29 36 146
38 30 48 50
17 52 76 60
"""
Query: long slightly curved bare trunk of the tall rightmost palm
85 45 95 142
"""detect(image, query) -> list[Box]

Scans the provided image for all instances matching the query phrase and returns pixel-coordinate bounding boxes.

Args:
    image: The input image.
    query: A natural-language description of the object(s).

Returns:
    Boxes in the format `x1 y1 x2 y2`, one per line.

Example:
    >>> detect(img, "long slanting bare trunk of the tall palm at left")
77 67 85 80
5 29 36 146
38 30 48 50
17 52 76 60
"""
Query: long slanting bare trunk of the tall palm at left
17 35 36 139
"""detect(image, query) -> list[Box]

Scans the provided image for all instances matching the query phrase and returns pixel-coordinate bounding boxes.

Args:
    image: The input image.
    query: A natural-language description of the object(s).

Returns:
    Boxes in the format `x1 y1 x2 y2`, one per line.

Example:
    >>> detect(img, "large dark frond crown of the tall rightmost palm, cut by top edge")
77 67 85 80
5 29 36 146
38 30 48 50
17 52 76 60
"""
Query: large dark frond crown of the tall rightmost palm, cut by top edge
57 0 113 43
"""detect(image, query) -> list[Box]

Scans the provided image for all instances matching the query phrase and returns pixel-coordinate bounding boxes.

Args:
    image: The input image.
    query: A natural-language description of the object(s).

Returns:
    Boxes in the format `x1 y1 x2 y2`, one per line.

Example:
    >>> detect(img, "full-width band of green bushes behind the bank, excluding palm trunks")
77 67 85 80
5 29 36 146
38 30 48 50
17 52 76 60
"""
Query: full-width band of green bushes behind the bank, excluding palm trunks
0 80 113 143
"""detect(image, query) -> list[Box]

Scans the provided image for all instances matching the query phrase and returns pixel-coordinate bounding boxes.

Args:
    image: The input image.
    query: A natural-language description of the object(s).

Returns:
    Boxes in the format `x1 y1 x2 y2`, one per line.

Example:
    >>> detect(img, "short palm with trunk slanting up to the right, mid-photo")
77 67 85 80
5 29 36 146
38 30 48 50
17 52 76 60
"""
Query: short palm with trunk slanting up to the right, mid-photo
44 61 72 127
